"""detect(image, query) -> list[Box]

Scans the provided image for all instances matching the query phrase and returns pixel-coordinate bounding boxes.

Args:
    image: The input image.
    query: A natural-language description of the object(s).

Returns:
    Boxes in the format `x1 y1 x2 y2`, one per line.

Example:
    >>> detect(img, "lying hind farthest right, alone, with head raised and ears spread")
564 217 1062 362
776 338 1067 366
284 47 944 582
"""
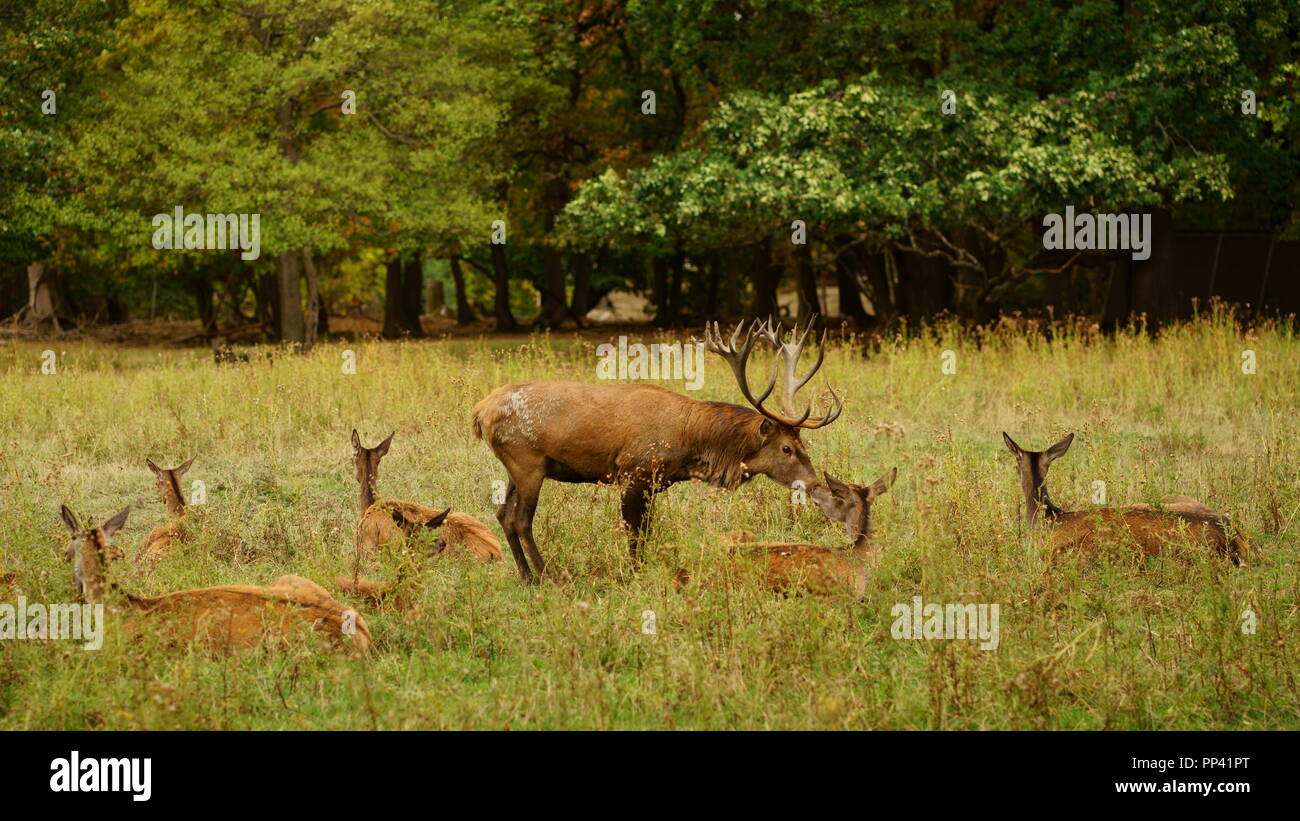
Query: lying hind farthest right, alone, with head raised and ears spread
1002 433 1248 565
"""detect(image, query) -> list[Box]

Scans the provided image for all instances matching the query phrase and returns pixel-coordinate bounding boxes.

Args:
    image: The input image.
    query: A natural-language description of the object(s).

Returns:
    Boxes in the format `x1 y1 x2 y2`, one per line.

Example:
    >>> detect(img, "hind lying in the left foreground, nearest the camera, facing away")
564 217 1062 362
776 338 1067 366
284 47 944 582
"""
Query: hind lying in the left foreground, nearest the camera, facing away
61 507 371 652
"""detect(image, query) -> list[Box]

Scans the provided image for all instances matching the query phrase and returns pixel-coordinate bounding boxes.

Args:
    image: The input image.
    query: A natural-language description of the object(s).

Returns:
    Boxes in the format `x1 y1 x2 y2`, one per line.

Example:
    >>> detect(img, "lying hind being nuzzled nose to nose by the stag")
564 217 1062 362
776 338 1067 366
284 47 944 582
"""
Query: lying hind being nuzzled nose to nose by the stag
677 468 898 599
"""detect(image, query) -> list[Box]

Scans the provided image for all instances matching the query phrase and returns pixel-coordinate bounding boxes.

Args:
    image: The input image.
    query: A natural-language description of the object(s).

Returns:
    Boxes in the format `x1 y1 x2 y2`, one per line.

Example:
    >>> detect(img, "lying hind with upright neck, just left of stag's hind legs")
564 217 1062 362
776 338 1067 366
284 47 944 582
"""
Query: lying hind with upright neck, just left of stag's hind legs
352 430 501 564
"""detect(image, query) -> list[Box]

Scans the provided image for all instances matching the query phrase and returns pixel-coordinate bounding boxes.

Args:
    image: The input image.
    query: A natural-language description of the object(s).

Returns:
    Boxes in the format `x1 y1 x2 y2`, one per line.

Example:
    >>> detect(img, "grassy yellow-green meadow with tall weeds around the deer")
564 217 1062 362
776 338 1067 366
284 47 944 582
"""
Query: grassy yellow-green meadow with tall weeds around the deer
0 312 1300 730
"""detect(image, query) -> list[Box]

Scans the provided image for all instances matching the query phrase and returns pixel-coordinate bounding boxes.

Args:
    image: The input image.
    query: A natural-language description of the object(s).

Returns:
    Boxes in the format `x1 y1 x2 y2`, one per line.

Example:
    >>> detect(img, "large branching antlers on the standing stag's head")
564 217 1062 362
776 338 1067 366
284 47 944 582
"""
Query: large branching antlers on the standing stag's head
705 316 844 430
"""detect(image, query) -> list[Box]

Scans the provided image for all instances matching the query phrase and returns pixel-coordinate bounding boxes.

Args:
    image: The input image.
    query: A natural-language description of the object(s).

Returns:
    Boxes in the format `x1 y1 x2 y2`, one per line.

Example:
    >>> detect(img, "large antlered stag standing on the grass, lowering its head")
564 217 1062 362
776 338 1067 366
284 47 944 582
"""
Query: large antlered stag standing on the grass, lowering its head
472 315 842 582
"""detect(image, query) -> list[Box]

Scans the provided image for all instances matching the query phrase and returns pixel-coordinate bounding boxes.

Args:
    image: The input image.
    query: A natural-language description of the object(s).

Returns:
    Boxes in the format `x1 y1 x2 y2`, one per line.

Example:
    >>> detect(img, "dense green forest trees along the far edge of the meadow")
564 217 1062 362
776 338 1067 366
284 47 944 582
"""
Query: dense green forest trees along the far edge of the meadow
0 0 1300 346
